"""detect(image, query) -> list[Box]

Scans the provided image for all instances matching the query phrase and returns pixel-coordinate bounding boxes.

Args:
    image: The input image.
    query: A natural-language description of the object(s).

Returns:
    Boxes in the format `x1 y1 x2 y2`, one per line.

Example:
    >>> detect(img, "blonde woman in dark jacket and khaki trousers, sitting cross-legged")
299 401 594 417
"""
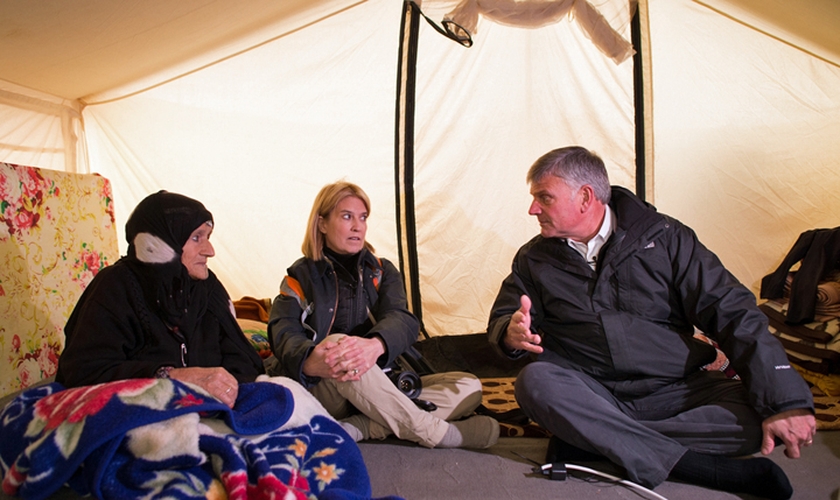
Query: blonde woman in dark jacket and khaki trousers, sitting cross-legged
268 182 499 448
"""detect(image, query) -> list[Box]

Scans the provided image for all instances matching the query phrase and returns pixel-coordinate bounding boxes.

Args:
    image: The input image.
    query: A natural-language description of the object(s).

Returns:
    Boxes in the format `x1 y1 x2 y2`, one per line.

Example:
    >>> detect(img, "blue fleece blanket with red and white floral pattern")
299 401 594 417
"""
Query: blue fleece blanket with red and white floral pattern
0 377 398 500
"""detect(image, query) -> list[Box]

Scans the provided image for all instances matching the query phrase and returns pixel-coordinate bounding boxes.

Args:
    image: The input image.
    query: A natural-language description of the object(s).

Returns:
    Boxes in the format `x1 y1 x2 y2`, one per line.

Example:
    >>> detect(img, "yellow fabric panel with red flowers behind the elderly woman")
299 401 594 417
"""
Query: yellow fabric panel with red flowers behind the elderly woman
0 163 119 396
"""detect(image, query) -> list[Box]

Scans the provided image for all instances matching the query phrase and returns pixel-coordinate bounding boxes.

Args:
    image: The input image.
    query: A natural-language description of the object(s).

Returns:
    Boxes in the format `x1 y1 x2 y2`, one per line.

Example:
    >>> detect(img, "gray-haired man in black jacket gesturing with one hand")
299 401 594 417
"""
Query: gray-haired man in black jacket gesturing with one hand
488 146 816 499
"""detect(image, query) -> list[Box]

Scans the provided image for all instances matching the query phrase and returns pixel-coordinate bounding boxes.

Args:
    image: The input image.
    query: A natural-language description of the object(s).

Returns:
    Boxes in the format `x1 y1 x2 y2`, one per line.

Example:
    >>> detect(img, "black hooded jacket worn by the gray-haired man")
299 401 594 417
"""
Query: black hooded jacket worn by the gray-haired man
488 187 812 417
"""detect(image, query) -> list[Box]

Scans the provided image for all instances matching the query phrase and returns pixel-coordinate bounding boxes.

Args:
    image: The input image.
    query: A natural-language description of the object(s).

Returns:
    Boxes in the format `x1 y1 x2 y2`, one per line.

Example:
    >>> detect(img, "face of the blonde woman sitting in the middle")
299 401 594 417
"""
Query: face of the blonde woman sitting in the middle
318 196 367 255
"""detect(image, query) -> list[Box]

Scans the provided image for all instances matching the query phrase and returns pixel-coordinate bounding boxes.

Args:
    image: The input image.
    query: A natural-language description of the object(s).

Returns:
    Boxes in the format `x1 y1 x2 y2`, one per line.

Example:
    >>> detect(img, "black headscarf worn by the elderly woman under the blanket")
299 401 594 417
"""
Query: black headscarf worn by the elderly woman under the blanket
124 191 213 336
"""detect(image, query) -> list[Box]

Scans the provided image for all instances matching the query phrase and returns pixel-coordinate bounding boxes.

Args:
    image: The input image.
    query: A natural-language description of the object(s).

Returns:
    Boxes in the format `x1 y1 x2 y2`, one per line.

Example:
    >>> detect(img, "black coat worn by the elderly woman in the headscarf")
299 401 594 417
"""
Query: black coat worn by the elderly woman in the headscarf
56 261 264 387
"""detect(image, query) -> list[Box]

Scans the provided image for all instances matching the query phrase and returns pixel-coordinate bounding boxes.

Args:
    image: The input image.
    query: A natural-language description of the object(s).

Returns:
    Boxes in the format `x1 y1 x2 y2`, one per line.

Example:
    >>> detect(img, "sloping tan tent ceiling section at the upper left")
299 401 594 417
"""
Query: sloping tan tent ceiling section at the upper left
0 0 364 99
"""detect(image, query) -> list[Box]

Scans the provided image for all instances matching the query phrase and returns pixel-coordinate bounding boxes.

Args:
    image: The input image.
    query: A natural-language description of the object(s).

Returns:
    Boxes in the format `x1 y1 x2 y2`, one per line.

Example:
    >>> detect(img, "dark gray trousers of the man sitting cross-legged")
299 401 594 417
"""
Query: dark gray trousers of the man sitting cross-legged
516 361 762 488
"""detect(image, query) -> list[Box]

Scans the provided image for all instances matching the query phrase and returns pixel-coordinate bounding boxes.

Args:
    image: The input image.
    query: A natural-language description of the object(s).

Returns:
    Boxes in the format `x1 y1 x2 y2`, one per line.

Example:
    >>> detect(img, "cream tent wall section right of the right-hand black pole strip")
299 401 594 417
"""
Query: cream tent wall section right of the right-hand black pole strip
648 0 840 293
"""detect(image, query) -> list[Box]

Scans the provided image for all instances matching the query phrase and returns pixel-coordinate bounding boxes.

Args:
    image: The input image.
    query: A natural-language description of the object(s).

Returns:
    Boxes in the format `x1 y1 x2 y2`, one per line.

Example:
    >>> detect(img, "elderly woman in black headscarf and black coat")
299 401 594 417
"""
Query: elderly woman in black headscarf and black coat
56 191 264 407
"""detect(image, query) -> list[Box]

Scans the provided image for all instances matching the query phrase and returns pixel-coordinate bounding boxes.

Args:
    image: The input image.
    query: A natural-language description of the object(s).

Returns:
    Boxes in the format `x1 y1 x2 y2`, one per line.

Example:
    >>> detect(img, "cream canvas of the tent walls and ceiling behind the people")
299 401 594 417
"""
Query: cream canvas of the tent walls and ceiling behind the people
0 0 840 335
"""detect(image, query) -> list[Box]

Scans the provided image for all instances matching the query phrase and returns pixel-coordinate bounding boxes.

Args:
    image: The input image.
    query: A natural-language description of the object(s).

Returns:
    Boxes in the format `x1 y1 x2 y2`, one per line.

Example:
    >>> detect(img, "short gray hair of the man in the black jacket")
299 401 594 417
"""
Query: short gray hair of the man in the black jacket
527 146 612 205
